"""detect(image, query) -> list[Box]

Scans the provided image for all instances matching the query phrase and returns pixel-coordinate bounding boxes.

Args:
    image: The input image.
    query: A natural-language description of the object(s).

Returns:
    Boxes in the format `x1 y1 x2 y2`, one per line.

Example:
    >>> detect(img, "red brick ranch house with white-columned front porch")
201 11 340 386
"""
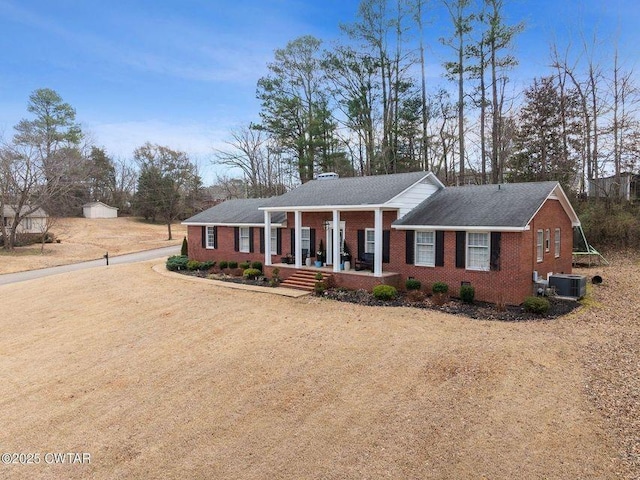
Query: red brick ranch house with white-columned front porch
184 172 580 304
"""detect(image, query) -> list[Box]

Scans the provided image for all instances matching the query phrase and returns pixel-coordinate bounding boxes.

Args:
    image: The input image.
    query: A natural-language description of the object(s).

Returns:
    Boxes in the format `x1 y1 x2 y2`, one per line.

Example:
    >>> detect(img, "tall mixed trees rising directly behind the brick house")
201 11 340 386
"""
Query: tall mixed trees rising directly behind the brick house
216 0 640 196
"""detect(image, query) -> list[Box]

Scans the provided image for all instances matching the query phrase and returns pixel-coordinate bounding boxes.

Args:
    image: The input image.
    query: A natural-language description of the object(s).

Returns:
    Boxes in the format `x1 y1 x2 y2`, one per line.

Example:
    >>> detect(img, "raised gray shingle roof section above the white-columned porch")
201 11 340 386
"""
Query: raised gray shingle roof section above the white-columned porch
264 172 428 207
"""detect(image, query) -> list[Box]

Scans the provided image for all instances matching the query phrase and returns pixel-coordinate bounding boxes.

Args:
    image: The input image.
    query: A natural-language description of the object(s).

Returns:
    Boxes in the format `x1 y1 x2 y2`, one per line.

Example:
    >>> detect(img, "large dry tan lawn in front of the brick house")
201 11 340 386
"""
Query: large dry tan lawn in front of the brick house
0 253 640 480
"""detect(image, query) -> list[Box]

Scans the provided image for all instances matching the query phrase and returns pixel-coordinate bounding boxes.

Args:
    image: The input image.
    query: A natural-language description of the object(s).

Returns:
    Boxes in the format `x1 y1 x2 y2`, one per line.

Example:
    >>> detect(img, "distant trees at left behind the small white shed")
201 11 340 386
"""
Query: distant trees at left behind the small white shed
0 88 202 250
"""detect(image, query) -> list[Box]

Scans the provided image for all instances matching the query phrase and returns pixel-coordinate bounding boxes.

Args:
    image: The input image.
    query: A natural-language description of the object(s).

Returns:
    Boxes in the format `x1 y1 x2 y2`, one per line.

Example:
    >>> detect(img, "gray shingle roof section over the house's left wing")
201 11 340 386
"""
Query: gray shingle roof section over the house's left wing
184 198 286 224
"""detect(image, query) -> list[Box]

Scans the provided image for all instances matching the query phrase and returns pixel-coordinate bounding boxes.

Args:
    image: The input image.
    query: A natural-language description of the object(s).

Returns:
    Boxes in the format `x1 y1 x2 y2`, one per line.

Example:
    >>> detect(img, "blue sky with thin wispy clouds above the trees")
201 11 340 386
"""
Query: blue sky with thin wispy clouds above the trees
0 0 640 183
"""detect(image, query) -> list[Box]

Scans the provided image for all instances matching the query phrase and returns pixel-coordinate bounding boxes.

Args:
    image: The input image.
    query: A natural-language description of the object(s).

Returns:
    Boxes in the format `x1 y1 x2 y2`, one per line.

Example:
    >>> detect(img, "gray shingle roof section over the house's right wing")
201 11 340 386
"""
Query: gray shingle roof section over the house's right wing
393 182 558 228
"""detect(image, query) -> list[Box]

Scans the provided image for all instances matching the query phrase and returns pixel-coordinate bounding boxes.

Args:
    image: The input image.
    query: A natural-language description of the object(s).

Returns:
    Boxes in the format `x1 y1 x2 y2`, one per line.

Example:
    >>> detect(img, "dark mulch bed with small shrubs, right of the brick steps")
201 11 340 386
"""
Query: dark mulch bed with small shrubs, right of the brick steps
322 288 580 322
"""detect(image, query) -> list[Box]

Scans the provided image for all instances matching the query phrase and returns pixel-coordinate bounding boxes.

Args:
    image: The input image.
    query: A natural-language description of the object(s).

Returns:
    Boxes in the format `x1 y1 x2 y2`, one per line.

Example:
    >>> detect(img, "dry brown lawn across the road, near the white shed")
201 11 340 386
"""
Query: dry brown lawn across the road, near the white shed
0 217 187 274
